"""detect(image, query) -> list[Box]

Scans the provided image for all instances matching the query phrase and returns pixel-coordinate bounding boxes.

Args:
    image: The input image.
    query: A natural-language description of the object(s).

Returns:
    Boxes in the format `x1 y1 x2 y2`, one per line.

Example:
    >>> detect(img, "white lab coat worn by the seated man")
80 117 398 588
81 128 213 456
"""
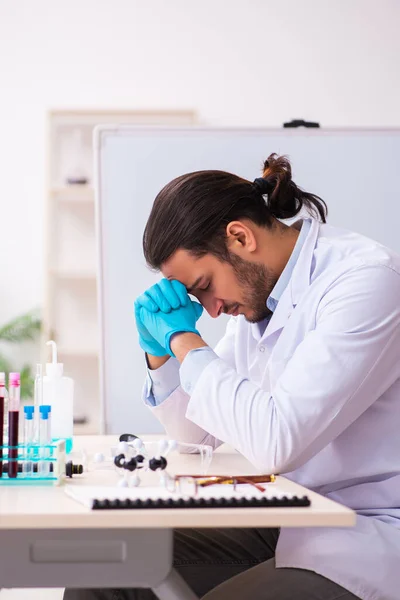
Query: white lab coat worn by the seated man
146 221 400 600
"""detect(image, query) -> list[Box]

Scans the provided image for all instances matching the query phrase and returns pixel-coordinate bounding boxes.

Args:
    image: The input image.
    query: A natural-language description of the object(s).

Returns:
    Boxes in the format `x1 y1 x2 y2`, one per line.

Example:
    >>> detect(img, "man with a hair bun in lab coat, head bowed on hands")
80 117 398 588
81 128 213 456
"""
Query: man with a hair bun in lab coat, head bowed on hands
68 155 400 600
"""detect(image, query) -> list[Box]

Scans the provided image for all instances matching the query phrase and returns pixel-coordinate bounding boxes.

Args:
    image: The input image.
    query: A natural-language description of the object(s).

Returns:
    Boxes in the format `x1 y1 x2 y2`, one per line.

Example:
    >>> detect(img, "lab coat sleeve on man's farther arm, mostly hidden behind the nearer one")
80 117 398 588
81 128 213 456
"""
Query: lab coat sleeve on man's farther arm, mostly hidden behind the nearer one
143 318 236 448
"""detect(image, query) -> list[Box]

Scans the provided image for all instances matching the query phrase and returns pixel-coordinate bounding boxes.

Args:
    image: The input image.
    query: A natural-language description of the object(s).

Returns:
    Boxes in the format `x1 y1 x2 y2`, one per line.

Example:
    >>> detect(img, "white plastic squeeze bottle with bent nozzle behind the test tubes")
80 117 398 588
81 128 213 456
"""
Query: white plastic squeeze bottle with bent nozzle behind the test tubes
43 340 74 453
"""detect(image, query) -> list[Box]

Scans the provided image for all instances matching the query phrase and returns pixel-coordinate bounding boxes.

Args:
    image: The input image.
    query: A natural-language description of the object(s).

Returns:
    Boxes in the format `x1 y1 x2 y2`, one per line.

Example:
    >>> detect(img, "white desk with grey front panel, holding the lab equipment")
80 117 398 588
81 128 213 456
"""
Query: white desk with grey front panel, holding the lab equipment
0 436 355 600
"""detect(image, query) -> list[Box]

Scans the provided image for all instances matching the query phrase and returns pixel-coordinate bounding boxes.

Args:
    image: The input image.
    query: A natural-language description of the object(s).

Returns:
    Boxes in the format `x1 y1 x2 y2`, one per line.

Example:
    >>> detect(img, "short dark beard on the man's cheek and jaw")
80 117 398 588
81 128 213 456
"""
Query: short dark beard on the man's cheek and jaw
230 254 278 323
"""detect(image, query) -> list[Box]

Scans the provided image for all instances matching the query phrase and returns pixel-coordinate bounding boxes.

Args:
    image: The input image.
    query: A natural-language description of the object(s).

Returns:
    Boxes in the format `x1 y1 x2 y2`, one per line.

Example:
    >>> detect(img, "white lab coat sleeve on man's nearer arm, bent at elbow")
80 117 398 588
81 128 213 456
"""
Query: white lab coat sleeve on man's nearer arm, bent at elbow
186 265 400 473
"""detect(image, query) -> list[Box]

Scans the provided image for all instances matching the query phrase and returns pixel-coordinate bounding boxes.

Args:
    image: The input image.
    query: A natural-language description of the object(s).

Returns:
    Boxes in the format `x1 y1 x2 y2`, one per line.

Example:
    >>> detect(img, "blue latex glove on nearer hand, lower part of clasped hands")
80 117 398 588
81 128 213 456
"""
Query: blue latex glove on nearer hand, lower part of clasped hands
139 300 203 356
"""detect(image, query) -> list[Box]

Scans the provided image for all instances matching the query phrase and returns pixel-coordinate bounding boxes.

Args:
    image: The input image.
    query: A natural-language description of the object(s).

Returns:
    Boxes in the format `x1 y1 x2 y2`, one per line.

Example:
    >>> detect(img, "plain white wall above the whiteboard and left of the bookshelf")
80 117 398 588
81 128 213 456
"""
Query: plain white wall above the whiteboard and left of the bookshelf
0 0 400 336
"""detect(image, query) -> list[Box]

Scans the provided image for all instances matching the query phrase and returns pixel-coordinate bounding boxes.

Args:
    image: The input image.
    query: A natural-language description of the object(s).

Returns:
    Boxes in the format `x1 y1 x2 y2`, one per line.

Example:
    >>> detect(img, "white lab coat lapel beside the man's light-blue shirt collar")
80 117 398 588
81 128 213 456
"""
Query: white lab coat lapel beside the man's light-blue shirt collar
258 219 320 345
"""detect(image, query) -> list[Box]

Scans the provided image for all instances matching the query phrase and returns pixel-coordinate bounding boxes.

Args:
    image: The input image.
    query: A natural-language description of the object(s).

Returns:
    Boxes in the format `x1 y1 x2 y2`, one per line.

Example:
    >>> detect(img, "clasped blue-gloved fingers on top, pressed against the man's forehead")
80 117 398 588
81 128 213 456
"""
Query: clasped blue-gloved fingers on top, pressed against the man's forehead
135 279 190 313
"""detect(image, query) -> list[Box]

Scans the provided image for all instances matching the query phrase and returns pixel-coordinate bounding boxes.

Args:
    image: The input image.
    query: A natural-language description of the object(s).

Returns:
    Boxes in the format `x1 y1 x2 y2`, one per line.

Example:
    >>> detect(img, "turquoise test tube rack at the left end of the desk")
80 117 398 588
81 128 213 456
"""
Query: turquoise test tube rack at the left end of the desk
0 440 78 486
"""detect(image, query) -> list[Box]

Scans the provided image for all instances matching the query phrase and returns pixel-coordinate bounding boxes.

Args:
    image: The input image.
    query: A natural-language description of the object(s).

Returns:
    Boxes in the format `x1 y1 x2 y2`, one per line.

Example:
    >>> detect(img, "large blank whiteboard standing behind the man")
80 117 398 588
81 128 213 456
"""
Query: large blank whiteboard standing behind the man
94 126 400 433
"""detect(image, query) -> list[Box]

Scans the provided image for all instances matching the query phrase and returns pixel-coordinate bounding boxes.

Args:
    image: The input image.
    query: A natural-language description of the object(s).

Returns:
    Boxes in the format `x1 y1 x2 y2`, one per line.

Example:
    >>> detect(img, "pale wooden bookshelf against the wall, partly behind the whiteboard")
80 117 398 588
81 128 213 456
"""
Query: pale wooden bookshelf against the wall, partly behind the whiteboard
41 110 196 434
